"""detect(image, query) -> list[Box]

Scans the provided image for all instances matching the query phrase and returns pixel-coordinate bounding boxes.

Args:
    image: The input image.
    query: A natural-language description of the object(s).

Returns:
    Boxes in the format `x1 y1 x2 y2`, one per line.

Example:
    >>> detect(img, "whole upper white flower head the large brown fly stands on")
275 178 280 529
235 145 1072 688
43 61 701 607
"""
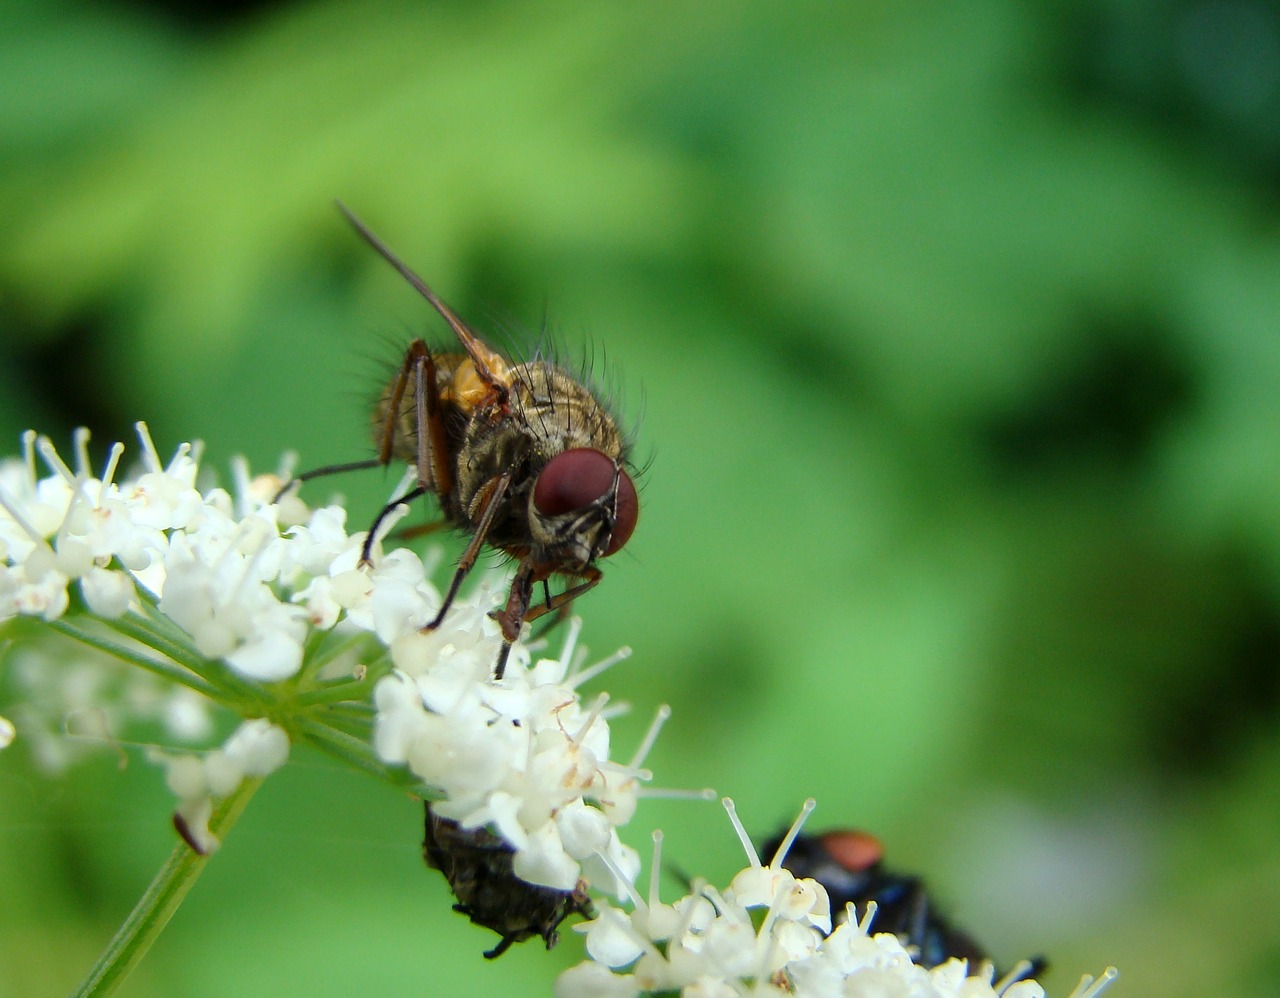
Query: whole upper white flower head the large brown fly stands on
0 424 667 891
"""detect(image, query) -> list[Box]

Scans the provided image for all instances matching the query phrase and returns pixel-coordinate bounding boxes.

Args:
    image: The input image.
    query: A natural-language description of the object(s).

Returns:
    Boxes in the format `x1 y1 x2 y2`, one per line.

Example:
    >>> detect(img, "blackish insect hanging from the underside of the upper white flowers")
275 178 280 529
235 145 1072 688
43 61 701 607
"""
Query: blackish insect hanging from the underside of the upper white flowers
422 804 595 960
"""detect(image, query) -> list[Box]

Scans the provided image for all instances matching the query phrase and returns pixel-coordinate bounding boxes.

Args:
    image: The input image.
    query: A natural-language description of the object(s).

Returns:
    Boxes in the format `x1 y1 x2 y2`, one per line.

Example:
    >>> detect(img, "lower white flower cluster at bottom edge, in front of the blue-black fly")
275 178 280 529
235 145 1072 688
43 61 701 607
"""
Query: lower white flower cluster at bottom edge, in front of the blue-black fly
556 801 1116 998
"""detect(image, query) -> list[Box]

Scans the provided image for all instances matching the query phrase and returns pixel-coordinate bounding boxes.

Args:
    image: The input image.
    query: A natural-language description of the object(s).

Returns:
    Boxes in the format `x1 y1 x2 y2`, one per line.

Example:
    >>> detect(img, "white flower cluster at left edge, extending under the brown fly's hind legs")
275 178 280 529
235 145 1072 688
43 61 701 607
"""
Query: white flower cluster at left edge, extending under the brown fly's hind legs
0 424 455 682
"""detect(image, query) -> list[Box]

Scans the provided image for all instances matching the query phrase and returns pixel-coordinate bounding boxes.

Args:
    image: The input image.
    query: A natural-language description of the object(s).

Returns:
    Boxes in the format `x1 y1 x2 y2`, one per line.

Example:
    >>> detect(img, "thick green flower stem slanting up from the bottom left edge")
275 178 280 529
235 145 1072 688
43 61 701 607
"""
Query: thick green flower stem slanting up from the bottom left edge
74 779 262 998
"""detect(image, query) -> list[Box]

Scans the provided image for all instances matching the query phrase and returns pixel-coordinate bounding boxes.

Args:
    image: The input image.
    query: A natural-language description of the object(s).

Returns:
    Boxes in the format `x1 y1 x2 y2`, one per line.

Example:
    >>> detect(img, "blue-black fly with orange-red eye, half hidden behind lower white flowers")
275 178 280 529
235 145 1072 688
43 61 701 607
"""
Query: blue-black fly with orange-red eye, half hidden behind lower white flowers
762 830 1048 983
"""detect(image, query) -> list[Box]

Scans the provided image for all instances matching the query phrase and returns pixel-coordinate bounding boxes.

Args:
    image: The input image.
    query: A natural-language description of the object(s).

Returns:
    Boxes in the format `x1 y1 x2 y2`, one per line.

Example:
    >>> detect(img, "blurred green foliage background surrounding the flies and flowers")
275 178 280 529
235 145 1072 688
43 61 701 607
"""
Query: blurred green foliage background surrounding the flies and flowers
0 0 1280 997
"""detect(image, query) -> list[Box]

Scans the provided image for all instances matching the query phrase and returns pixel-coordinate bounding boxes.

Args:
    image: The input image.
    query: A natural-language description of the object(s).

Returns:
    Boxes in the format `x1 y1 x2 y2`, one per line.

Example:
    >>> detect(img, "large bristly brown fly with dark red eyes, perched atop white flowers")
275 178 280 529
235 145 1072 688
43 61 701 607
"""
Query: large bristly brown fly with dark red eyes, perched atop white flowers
287 203 640 678
